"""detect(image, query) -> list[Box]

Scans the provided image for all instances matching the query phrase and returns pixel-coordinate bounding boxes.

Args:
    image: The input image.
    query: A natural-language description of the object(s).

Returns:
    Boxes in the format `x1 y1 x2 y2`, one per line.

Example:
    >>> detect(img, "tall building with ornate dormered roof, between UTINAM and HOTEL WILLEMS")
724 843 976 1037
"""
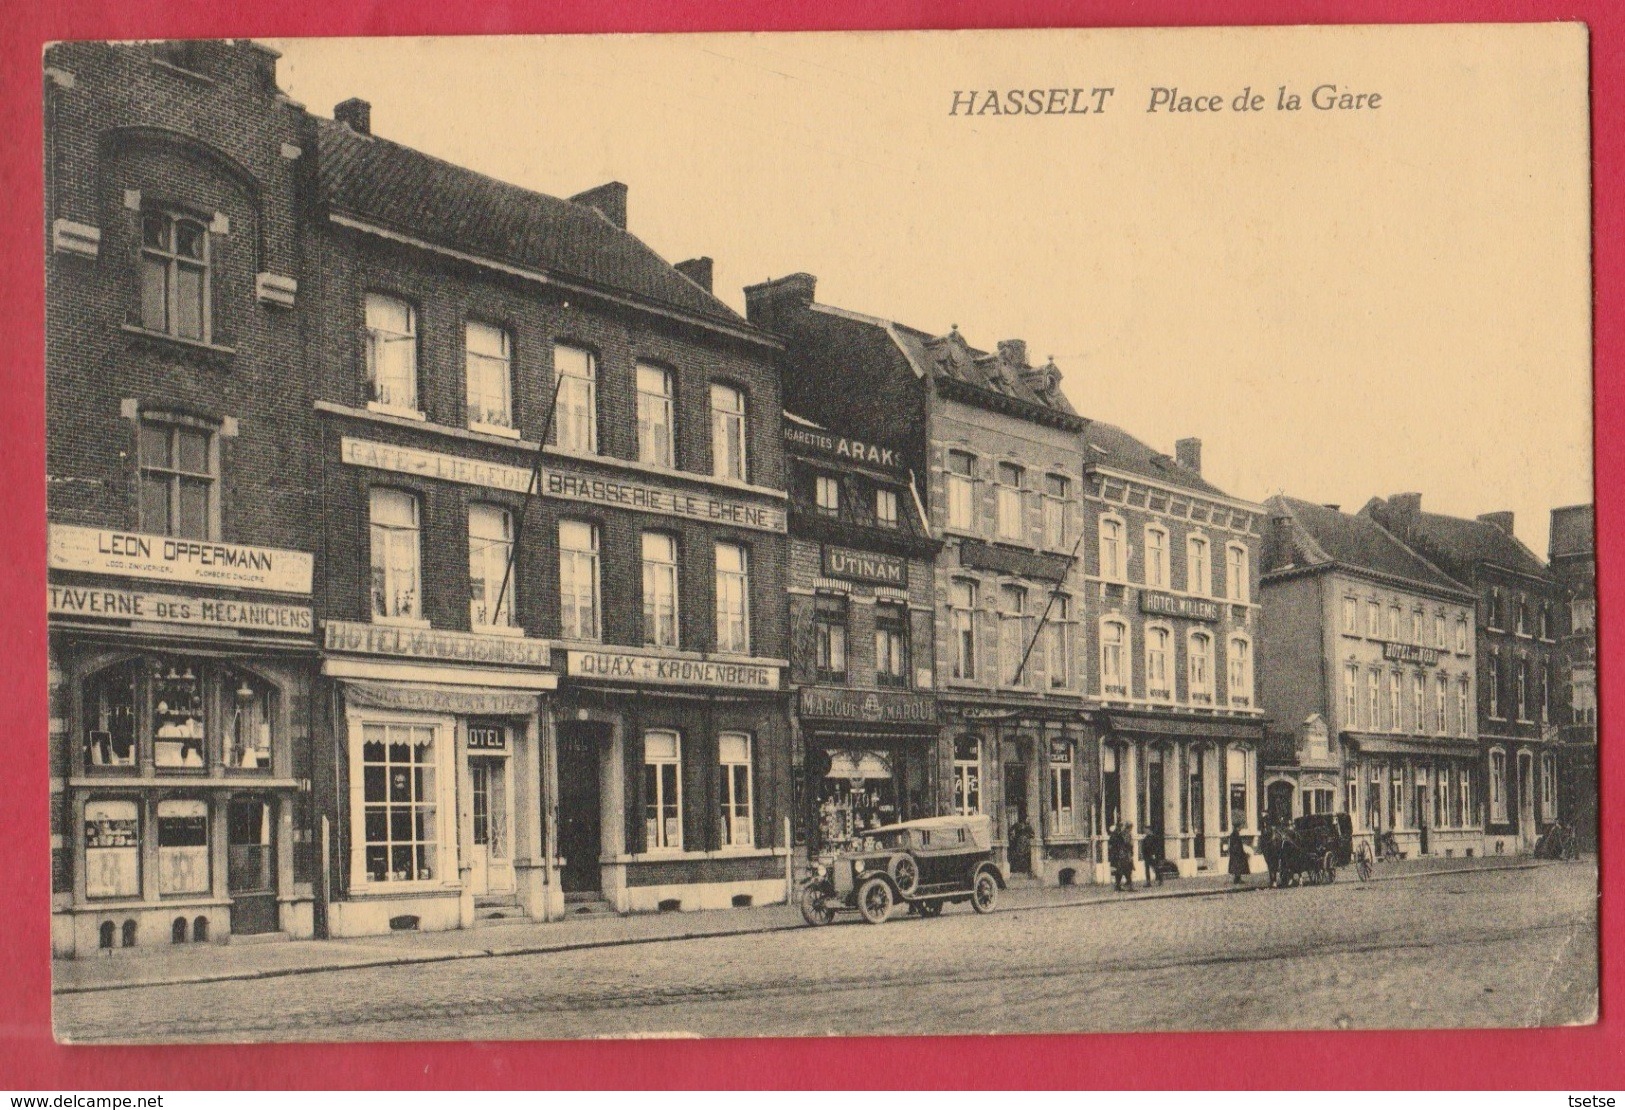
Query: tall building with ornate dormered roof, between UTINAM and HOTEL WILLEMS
746 273 1094 882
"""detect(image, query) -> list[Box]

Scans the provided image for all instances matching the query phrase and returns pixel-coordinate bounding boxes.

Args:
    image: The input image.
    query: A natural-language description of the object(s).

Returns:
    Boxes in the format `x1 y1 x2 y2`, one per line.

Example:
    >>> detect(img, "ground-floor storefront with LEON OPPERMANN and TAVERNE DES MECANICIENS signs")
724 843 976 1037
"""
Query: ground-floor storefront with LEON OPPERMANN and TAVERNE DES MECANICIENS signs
47 525 315 956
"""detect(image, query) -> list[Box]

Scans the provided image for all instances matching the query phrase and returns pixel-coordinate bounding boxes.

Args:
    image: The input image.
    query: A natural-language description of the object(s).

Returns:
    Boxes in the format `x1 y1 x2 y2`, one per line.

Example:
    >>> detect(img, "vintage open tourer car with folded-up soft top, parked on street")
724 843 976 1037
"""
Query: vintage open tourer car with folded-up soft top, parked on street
801 816 1004 925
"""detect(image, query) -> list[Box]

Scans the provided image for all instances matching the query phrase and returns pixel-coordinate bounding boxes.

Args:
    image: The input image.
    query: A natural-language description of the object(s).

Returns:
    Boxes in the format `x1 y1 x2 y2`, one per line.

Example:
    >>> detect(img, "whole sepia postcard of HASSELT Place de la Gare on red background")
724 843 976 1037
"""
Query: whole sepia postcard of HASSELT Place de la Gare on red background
44 24 1597 1043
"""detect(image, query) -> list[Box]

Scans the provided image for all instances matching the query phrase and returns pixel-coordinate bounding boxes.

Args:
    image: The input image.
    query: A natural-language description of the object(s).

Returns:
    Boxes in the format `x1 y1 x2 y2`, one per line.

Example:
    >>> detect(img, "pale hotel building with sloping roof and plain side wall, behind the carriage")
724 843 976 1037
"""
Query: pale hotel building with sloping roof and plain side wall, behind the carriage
1259 497 1505 856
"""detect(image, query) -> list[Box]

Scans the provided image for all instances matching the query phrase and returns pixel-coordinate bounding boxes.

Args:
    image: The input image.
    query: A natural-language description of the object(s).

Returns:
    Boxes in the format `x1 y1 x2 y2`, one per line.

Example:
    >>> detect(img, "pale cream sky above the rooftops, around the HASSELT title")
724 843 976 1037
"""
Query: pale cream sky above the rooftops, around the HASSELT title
271 26 1591 557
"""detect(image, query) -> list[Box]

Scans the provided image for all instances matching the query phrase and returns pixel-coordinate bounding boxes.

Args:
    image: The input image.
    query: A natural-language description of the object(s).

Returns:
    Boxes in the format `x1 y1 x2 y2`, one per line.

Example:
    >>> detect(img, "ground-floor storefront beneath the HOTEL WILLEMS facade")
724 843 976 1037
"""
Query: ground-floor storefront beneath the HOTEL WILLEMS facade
1094 710 1264 882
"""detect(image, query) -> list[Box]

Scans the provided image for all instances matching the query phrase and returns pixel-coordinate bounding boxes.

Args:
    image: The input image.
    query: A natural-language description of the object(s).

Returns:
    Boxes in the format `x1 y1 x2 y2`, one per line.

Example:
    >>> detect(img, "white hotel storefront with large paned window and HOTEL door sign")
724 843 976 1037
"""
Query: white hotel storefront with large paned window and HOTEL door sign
322 621 564 936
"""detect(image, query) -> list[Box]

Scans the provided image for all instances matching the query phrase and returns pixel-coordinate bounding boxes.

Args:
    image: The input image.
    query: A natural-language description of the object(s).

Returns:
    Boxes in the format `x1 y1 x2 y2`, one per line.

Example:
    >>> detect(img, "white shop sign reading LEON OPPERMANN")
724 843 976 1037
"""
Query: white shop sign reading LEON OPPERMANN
49 525 312 593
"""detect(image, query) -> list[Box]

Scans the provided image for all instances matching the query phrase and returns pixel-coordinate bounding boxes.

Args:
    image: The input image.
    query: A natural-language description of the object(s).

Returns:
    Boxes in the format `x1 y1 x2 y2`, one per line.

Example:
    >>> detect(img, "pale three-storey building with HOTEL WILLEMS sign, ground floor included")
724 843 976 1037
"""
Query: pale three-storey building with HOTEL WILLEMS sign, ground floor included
1081 421 1264 881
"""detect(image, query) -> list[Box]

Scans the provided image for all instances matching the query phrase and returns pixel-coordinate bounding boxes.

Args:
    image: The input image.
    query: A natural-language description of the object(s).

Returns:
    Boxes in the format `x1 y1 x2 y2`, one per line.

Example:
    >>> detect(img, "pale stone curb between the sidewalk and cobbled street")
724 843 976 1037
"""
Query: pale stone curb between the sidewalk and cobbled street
52 861 1542 995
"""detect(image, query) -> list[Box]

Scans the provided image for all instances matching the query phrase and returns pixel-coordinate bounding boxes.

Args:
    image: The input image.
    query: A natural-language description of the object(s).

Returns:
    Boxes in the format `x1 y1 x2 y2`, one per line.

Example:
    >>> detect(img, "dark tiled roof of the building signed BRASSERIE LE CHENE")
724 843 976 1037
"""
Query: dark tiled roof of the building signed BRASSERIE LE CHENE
317 120 748 328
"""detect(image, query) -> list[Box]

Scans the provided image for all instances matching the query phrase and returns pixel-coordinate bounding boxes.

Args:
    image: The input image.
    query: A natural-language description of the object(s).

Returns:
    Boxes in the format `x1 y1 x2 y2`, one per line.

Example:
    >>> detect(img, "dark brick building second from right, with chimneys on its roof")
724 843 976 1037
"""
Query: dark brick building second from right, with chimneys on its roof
1360 494 1565 852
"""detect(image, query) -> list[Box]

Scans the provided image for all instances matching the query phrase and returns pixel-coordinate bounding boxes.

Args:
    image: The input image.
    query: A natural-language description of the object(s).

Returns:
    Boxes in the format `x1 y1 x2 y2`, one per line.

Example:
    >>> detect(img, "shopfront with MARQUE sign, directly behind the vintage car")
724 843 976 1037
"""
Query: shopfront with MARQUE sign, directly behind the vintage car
796 686 938 853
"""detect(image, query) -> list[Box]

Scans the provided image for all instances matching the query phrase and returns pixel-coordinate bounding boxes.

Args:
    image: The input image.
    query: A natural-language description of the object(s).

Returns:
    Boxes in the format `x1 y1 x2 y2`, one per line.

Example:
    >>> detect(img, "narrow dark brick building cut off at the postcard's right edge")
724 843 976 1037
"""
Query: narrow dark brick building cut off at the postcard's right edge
1549 505 1597 848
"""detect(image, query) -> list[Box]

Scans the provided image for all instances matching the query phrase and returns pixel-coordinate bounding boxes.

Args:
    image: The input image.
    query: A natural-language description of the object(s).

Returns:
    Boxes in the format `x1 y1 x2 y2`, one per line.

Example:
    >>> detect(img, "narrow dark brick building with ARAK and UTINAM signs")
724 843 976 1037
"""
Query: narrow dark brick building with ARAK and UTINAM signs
785 413 941 852
